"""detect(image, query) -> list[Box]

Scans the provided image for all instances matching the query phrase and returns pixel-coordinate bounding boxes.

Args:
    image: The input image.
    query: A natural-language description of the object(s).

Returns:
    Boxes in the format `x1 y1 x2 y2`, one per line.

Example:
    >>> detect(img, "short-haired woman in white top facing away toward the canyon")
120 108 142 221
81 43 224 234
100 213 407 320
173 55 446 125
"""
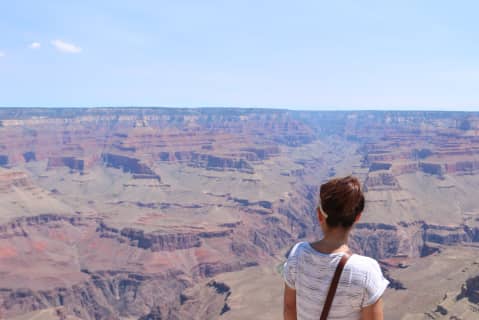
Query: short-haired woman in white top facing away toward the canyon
283 176 389 320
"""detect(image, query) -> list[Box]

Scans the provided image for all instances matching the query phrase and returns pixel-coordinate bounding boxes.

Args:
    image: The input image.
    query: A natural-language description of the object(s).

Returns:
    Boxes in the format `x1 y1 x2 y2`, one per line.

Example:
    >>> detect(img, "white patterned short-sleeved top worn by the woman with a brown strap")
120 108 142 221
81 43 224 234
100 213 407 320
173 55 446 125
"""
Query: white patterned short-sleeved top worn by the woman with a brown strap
283 242 389 320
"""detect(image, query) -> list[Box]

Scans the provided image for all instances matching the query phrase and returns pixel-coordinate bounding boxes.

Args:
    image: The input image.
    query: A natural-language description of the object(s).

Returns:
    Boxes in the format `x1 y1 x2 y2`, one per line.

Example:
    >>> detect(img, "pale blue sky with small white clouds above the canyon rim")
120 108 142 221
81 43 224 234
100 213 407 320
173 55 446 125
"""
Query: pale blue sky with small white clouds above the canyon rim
0 0 479 110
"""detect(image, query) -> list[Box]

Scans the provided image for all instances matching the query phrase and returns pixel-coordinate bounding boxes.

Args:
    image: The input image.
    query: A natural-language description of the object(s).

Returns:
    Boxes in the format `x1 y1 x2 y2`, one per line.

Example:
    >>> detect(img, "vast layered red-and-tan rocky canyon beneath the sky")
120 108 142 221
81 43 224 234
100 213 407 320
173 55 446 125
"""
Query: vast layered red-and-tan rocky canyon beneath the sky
0 108 479 320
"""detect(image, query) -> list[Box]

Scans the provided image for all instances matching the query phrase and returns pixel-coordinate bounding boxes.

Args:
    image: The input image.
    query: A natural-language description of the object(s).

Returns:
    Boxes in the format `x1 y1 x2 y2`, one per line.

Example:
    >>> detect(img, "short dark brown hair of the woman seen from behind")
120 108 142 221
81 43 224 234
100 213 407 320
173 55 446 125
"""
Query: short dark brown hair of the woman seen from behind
319 176 364 228
